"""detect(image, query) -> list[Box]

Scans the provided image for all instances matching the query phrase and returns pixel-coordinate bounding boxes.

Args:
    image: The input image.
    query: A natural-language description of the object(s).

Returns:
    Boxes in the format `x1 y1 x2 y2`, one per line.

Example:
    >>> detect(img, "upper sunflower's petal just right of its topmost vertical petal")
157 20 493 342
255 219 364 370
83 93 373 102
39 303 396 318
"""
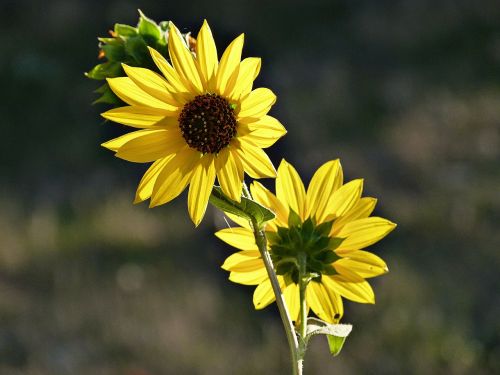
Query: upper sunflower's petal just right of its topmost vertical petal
216 34 245 96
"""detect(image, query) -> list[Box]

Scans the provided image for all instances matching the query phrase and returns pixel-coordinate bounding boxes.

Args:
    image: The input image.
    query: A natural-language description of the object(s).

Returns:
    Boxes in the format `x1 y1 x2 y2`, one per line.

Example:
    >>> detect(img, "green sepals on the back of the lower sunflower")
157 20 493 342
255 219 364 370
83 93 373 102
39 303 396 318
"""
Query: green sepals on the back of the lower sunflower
268 210 343 284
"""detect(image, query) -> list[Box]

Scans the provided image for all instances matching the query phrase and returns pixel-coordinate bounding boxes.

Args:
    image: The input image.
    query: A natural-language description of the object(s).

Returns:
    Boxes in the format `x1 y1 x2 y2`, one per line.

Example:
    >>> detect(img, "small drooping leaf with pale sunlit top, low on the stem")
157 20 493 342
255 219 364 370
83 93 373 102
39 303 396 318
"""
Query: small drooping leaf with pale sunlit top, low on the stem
304 318 352 356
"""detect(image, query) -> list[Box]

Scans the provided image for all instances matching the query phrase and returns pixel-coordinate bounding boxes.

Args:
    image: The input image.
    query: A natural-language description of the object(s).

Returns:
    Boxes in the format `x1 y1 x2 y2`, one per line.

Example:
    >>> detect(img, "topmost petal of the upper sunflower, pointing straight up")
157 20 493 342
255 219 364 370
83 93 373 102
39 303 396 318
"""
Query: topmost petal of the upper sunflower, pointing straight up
196 20 218 91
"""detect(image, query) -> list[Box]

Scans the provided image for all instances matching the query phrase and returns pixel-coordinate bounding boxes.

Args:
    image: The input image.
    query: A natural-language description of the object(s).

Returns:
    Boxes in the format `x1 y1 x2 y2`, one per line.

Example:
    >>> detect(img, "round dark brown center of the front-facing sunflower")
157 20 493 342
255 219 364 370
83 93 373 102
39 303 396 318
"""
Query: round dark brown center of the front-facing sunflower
179 94 237 154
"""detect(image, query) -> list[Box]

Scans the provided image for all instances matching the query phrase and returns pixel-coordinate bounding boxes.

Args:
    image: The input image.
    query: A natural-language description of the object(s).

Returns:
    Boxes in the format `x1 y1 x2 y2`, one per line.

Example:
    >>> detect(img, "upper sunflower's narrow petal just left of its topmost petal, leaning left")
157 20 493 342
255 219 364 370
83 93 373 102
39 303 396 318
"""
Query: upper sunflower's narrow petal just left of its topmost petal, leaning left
168 22 203 93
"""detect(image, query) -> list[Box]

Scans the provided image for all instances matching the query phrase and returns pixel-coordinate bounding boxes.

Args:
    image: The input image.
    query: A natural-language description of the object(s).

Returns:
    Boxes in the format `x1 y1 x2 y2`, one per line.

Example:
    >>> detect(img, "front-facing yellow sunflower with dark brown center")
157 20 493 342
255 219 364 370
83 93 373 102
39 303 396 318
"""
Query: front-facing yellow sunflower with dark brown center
102 21 286 225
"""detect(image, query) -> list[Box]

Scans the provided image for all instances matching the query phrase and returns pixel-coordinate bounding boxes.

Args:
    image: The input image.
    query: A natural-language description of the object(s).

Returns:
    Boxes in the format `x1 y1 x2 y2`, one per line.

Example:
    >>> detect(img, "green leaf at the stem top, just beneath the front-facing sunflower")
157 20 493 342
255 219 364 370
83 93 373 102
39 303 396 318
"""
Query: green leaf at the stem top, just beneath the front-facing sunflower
209 186 275 227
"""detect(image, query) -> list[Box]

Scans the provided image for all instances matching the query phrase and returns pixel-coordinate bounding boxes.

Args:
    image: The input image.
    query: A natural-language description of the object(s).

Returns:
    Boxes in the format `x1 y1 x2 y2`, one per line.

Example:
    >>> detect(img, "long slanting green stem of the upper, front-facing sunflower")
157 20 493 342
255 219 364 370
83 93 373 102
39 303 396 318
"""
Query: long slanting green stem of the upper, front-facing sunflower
252 219 302 375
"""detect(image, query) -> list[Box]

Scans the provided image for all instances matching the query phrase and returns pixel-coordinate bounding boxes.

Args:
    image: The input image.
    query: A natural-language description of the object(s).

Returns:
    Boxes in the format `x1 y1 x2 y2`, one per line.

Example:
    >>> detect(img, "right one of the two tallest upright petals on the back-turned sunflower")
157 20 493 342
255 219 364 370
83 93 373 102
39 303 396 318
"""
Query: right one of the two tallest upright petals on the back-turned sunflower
306 159 343 223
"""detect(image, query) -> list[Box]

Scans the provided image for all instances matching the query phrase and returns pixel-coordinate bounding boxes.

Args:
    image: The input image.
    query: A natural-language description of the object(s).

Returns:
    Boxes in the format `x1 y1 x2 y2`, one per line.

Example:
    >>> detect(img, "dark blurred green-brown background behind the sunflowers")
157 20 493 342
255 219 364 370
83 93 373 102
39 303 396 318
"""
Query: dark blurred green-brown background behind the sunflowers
0 0 500 375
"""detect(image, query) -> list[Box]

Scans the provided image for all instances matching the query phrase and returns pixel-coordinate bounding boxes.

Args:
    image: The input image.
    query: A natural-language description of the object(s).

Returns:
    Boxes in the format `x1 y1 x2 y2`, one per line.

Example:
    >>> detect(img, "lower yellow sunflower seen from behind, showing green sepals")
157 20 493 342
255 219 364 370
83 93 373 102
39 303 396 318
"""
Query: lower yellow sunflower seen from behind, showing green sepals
216 160 396 323
